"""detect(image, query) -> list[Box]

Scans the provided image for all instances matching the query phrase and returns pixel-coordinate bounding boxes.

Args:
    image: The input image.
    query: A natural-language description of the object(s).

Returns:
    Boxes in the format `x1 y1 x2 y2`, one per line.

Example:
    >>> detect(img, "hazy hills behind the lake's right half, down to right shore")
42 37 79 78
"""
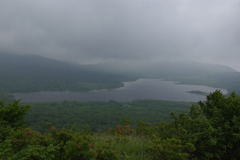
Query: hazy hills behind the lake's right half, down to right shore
85 61 240 94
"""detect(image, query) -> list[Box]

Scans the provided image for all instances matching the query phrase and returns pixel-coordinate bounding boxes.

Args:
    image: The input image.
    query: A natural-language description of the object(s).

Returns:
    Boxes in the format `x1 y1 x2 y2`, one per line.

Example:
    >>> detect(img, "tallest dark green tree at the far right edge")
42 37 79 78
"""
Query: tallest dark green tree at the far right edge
199 90 240 159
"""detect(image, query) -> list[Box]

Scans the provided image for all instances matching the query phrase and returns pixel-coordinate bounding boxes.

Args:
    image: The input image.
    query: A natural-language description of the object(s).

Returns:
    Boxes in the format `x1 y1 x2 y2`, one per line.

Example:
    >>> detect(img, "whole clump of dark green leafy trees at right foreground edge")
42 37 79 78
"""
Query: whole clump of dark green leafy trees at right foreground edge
172 90 240 159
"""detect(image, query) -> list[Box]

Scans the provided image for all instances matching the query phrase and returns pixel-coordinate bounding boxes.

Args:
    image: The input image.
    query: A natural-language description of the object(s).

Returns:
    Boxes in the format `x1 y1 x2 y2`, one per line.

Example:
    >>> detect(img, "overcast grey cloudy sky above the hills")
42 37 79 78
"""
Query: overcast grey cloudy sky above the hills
0 0 240 71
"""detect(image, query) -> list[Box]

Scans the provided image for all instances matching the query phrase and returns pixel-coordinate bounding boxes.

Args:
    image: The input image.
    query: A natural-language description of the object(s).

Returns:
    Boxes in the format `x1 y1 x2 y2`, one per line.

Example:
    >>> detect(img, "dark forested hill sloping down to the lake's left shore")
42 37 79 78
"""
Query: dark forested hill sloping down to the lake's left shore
0 54 137 92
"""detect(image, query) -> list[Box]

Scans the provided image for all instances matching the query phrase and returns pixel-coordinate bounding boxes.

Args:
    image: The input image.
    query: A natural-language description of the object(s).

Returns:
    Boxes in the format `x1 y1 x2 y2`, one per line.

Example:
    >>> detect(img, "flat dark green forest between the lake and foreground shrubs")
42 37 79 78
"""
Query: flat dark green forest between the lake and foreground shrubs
24 100 191 132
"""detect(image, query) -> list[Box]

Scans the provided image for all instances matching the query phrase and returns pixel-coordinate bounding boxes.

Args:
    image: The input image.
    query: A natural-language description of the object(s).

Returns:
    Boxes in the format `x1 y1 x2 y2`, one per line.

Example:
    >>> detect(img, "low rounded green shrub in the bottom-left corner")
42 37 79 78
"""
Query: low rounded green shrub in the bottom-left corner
0 128 59 160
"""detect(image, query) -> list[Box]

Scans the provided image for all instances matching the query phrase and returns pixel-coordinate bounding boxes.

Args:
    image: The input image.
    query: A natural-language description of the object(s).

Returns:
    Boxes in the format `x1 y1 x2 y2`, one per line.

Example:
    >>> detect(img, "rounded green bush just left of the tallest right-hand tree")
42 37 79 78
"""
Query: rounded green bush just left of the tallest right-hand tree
172 105 216 159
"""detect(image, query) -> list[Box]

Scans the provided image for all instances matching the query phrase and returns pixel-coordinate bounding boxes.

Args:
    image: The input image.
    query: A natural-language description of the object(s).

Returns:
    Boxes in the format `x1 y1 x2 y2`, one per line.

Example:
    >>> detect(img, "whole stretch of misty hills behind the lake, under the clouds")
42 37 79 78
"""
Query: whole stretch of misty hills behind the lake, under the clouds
0 54 240 97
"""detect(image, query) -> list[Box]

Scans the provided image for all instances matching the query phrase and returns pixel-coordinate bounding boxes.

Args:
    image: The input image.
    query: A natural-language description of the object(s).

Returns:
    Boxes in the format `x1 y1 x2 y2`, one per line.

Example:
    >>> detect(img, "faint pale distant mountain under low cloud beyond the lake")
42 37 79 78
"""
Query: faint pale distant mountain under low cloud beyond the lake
83 61 236 78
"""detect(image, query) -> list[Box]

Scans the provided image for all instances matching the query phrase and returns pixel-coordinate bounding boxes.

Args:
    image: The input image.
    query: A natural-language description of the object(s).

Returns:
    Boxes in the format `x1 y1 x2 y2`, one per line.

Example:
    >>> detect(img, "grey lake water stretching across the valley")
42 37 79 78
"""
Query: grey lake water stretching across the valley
14 79 227 102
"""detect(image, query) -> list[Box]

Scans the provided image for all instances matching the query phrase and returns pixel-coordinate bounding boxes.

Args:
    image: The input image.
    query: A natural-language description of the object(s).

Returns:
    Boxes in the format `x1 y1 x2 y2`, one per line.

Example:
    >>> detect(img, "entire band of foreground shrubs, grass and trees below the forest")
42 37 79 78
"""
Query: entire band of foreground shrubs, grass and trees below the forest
0 91 240 160
